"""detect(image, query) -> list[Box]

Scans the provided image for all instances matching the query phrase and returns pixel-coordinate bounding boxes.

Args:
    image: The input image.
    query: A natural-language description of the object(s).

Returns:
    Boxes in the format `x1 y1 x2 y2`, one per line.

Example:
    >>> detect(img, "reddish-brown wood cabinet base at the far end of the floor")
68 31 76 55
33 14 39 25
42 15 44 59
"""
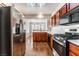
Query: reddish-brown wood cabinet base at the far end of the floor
33 32 48 42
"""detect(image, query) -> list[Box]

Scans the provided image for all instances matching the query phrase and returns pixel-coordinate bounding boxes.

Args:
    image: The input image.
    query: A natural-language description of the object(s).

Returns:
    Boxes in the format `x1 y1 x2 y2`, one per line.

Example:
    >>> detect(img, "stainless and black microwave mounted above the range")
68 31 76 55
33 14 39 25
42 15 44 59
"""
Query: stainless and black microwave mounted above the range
60 12 79 25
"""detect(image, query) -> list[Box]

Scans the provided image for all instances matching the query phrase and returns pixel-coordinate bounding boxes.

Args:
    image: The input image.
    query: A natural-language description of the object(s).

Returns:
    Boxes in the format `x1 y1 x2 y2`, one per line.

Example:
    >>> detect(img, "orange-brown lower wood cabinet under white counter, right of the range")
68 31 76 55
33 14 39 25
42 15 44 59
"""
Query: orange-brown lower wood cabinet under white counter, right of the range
69 43 79 56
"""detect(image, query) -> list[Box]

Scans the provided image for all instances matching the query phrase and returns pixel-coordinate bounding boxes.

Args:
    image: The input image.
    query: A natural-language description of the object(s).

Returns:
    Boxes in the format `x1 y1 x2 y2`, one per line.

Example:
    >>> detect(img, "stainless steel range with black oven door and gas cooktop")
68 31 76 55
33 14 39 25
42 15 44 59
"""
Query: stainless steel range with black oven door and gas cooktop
54 34 66 56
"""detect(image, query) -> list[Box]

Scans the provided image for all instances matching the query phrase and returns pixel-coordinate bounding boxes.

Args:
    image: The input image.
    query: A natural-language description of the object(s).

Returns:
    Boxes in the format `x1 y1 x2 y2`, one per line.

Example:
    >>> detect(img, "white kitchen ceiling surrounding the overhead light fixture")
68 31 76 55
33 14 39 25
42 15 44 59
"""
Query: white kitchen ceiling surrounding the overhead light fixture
14 3 59 14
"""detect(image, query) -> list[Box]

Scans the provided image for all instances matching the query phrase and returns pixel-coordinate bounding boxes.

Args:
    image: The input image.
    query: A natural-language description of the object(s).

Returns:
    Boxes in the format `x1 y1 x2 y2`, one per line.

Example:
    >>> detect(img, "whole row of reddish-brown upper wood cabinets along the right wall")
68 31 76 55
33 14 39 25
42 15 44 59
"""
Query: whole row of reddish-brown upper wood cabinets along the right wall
49 3 79 27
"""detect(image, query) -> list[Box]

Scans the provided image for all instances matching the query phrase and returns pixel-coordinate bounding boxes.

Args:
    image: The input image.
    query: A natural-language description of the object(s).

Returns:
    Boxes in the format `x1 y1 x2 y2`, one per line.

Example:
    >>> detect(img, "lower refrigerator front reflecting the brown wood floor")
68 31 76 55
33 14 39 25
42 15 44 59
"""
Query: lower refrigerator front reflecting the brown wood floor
13 43 25 56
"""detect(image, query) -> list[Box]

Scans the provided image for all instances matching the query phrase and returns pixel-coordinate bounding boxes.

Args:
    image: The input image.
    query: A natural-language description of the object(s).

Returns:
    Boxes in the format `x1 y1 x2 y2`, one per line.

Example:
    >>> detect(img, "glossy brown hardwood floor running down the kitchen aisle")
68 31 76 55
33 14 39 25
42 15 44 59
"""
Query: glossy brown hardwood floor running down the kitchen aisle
25 34 53 56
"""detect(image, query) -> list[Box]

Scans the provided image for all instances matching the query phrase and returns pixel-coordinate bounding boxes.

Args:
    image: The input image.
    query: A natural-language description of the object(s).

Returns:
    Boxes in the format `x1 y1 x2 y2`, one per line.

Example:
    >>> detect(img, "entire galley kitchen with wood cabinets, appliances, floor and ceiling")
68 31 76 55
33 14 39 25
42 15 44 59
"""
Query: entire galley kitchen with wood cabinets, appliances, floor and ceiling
0 3 79 56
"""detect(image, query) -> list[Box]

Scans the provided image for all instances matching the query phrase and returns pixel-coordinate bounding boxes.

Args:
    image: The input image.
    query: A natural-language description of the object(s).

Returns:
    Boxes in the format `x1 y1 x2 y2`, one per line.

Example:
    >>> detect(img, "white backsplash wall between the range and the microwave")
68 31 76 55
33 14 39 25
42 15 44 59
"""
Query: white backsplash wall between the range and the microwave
51 24 79 34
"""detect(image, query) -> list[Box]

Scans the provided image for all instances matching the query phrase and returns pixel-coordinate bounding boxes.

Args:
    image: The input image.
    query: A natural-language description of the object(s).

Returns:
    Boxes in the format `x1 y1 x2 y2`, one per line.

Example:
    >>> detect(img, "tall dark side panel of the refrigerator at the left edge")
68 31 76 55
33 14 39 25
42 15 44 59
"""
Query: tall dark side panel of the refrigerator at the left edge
0 7 12 56
